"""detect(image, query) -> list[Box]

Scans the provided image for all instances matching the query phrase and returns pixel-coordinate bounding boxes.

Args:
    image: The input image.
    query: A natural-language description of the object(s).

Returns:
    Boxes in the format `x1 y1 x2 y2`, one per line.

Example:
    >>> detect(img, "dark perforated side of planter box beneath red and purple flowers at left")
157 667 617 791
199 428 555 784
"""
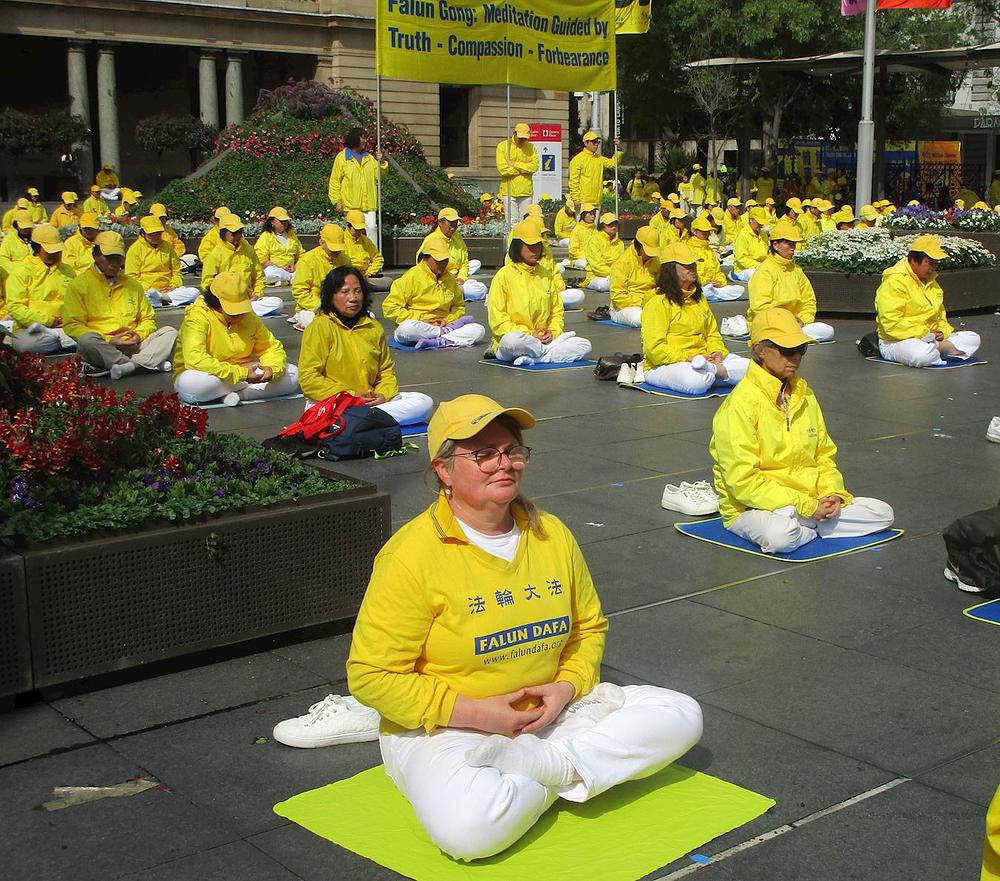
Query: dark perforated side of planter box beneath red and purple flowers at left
17 470 390 689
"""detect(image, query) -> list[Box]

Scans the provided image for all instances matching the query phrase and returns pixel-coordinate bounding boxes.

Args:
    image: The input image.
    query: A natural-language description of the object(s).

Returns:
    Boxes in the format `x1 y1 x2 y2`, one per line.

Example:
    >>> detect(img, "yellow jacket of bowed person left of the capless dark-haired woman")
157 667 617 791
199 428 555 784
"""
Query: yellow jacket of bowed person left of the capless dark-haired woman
174 297 287 382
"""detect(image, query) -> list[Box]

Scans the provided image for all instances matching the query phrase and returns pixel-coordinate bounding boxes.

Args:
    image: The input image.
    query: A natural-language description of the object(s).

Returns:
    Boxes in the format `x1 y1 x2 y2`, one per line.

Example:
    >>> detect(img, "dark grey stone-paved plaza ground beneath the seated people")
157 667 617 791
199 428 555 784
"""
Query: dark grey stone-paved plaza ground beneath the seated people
0 279 1000 881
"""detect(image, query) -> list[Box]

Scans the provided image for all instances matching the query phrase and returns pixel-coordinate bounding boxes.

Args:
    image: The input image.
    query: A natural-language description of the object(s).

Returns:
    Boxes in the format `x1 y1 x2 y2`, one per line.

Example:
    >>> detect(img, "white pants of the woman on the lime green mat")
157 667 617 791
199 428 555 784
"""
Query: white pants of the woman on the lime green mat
379 685 702 860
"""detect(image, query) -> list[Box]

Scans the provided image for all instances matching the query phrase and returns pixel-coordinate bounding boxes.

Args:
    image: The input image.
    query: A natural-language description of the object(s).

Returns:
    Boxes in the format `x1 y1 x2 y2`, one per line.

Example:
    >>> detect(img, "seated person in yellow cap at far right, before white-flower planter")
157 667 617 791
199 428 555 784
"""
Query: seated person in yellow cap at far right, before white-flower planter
875 235 981 367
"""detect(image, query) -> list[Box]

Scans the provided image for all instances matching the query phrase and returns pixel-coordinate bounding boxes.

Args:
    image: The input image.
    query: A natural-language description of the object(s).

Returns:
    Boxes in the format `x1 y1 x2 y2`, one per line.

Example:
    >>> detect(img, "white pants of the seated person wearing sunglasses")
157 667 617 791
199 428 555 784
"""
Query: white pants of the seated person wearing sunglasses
728 498 895 554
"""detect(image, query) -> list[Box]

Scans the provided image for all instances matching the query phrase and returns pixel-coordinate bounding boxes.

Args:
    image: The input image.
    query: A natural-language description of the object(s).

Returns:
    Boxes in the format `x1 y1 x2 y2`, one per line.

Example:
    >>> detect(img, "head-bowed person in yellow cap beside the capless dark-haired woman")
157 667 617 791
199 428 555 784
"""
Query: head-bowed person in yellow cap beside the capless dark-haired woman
174 271 299 407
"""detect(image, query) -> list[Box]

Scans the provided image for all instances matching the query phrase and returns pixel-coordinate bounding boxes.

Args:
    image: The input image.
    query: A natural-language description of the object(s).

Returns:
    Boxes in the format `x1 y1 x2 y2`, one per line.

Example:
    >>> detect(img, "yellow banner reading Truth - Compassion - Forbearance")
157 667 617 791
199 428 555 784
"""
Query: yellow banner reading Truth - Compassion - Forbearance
375 0 616 92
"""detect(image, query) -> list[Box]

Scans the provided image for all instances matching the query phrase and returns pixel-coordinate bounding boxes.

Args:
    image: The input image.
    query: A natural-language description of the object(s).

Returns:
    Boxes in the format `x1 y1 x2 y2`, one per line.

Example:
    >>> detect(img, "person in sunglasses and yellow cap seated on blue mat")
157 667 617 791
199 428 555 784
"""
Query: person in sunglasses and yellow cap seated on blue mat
709 308 893 554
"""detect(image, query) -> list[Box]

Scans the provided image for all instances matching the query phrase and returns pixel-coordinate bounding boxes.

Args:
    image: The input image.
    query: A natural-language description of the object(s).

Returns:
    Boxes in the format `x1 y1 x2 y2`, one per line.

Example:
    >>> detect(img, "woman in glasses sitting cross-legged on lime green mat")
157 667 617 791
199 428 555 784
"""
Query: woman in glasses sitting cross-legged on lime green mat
347 394 702 860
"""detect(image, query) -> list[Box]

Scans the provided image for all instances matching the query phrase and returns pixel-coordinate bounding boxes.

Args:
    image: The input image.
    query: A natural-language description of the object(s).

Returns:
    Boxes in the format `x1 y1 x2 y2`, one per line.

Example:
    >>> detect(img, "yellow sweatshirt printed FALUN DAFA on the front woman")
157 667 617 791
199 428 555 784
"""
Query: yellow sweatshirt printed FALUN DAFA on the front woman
347 494 608 733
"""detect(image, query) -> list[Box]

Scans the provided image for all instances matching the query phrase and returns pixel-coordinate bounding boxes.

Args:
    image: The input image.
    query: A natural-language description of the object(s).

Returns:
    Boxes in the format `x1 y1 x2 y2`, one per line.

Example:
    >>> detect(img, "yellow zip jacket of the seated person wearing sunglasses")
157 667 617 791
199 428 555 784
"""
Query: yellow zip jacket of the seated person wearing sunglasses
708 362 853 526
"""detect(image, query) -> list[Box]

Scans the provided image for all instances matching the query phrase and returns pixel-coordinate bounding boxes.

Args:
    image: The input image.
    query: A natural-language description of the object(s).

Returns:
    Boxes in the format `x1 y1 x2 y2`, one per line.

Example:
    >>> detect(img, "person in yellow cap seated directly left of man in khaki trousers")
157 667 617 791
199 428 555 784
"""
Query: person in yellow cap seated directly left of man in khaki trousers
6 224 76 355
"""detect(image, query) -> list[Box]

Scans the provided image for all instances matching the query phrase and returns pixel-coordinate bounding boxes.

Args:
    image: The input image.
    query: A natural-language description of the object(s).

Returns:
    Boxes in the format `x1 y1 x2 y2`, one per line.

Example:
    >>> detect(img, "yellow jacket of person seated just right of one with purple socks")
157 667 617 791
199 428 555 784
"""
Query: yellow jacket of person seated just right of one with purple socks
486 263 563 344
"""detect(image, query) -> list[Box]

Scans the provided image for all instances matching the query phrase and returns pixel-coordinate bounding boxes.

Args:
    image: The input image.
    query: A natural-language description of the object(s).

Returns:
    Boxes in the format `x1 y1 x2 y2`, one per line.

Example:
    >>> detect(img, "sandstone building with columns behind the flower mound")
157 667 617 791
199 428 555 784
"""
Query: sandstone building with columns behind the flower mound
0 0 570 201
